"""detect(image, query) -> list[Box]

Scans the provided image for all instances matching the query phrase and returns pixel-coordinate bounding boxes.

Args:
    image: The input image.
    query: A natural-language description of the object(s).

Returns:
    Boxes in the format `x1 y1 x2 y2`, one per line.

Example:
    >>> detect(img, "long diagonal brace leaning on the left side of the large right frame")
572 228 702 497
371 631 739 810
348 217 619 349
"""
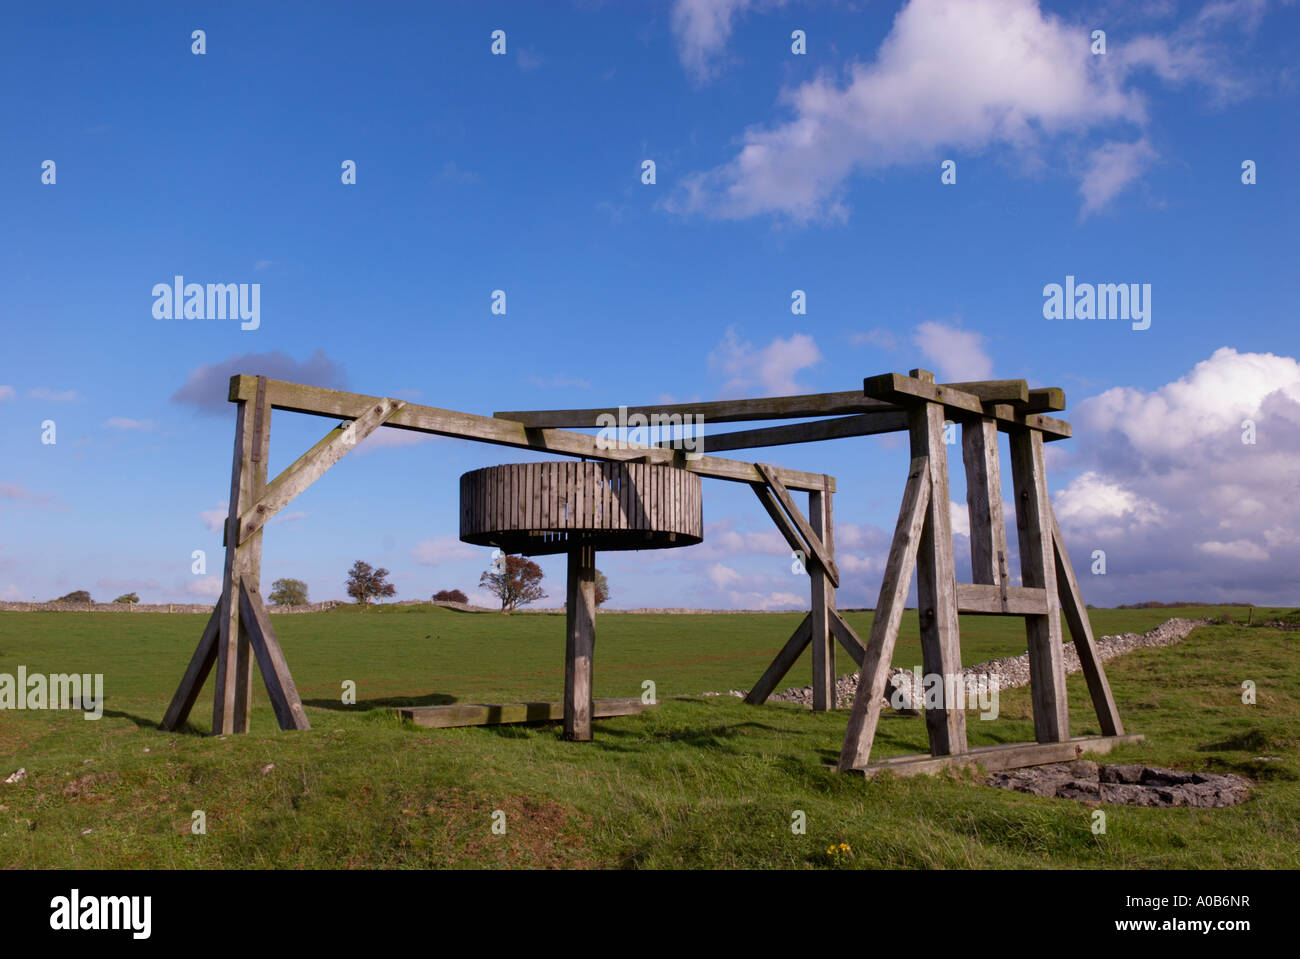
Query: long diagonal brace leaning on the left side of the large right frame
840 456 931 771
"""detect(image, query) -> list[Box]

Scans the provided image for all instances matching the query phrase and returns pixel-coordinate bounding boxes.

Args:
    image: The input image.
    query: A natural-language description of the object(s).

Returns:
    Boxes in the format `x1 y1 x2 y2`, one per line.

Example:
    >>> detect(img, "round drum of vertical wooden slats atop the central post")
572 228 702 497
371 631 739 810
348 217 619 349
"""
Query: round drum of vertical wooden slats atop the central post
460 463 703 556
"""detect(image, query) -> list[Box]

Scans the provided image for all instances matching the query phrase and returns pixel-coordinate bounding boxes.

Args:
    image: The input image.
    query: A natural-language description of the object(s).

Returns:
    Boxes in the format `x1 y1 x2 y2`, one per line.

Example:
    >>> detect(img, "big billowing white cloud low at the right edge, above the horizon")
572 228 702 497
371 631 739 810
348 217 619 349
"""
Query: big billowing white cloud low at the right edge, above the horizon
1053 347 1300 603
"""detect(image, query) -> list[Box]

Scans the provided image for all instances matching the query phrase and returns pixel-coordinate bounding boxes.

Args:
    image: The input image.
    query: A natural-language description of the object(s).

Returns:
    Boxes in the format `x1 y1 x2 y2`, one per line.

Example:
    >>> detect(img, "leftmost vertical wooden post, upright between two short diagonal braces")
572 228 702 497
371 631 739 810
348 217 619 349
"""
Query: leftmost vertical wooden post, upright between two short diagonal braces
212 377 270 734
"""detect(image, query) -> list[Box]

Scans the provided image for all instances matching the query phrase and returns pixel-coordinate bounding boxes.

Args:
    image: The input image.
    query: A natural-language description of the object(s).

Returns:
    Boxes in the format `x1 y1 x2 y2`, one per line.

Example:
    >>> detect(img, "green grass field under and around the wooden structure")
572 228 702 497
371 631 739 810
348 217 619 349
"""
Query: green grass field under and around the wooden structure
0 607 1300 868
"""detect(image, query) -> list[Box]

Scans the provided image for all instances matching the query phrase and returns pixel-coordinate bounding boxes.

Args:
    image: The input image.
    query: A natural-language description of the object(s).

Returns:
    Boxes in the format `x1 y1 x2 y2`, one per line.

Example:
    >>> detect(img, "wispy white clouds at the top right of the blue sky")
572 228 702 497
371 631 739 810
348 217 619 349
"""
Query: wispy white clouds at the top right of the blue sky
667 0 1268 222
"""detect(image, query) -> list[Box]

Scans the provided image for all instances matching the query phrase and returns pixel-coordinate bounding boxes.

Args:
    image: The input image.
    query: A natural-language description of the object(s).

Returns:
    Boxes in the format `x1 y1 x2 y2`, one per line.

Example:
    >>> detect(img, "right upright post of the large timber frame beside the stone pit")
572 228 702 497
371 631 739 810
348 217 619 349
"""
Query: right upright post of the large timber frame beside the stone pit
1010 429 1070 742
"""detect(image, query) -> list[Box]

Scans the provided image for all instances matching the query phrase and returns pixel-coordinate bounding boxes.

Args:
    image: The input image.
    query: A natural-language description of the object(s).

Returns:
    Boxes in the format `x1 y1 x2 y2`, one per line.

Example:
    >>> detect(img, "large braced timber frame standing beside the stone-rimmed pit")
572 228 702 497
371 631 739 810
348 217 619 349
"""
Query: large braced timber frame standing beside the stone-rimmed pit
839 370 1140 774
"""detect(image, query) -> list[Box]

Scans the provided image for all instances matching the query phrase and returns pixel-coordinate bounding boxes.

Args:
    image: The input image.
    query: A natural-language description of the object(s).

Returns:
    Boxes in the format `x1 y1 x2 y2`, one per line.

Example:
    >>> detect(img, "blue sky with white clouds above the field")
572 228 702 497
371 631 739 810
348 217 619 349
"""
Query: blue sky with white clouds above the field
0 0 1300 608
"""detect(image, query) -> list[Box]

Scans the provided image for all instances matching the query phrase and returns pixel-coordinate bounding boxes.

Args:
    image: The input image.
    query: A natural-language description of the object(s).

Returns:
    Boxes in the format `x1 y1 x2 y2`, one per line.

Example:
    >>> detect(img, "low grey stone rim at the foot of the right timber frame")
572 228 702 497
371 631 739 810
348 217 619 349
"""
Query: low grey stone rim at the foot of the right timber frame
987 759 1251 808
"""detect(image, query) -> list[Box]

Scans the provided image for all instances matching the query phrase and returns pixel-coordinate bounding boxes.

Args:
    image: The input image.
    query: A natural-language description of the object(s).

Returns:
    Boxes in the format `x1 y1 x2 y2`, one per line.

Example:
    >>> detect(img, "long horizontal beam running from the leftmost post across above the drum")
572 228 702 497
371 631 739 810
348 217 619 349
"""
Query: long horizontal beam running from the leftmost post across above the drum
230 374 835 491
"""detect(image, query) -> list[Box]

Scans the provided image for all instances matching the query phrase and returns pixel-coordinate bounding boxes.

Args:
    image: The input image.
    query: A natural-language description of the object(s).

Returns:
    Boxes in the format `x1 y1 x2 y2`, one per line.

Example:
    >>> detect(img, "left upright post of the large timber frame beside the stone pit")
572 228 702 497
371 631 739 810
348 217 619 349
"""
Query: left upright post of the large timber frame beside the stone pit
915 389 966 756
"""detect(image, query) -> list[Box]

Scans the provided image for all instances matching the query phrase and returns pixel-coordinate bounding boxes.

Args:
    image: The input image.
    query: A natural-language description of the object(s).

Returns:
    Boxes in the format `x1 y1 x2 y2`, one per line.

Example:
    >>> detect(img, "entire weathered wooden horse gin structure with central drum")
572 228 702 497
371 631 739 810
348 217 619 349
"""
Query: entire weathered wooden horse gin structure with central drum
163 370 1141 776
